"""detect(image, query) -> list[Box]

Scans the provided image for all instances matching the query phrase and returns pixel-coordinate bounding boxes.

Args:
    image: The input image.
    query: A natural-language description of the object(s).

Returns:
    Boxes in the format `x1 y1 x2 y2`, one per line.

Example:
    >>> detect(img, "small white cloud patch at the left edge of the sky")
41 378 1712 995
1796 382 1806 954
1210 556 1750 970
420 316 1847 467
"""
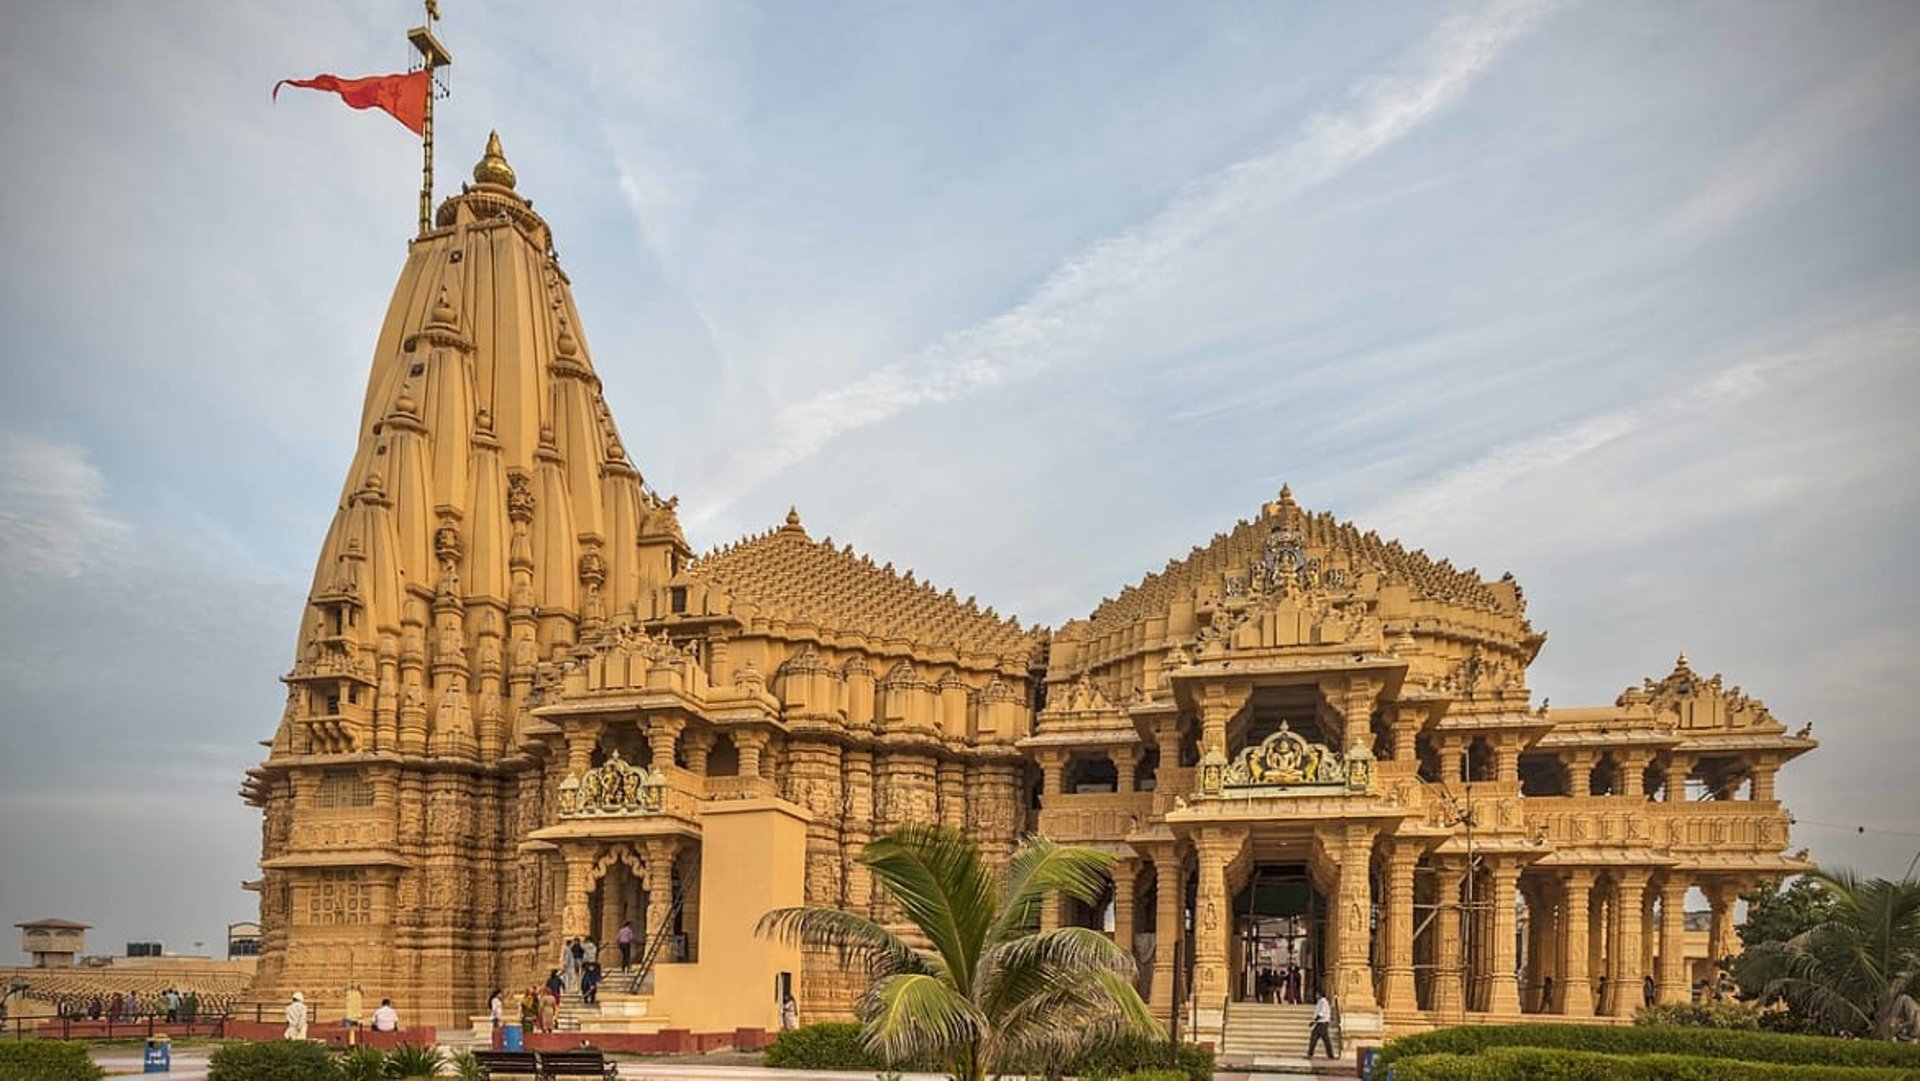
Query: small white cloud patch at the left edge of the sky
0 434 129 578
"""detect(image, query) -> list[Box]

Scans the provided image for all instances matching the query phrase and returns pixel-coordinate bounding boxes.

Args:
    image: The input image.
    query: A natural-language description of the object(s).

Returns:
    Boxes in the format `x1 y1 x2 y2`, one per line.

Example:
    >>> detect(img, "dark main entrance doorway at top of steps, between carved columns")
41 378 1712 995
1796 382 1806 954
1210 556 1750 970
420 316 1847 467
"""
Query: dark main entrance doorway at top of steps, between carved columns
1233 864 1327 1002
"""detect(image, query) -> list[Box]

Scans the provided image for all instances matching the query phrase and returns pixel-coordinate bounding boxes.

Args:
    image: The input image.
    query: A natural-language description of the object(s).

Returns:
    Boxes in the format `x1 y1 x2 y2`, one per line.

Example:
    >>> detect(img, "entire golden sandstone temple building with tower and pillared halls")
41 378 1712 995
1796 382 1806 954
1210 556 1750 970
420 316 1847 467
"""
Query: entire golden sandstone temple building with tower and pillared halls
244 138 1814 1045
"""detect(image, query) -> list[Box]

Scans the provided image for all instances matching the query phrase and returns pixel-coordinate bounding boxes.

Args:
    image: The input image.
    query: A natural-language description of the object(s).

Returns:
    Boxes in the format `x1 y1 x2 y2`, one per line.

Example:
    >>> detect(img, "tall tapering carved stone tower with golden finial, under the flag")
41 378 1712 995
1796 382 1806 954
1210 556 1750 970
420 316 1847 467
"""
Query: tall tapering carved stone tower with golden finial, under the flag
244 136 689 1018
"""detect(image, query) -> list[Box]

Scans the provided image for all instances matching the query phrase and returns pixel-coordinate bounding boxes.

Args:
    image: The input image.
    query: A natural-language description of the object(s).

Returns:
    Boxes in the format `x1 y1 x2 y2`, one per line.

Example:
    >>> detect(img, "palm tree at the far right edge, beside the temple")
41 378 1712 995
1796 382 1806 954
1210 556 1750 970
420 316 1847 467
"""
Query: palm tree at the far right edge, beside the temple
1736 868 1920 1039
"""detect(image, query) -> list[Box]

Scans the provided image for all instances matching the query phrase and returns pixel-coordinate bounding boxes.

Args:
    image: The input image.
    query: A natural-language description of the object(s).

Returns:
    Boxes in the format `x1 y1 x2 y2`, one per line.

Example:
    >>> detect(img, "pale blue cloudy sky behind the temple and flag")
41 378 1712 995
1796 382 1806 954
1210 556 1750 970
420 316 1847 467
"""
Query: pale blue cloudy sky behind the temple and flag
0 0 1920 958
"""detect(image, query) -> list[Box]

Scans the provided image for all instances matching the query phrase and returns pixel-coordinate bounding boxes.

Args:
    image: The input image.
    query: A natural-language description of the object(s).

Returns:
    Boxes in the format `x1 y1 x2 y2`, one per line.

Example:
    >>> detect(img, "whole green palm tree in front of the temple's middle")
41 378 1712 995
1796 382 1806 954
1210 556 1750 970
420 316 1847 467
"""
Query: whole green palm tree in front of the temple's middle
758 826 1160 1081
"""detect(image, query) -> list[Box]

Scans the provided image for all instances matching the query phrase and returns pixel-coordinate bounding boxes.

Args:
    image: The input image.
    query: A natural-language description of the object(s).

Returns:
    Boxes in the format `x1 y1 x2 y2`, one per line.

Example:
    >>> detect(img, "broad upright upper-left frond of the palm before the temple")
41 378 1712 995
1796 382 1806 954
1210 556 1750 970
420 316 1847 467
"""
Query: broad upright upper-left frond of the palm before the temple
860 824 995 987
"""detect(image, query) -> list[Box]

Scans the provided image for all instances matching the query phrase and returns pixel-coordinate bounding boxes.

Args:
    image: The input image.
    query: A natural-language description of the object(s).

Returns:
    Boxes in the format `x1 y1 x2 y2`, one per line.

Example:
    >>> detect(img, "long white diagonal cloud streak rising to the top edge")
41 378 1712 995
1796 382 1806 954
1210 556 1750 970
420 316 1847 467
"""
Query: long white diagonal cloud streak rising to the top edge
687 0 1546 526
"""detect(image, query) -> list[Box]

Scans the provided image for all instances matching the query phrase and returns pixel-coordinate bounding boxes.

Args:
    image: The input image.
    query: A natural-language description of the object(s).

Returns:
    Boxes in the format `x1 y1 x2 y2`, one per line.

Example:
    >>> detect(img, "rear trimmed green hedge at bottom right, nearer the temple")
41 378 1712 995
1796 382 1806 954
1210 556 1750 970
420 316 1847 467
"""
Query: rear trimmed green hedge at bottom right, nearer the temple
1377 1023 1920 1069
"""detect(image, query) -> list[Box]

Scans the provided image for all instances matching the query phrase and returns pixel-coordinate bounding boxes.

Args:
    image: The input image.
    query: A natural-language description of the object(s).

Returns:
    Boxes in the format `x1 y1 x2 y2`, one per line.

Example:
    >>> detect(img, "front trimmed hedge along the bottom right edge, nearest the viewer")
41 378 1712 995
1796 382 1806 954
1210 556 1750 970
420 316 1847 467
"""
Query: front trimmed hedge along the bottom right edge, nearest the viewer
1394 1046 1920 1081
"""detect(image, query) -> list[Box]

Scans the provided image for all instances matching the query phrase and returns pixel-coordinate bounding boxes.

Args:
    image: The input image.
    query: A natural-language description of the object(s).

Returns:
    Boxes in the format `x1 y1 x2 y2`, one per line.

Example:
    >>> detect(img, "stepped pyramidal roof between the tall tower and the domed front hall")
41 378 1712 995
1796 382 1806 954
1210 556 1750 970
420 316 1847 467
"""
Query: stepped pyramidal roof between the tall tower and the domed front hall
687 511 1039 661
